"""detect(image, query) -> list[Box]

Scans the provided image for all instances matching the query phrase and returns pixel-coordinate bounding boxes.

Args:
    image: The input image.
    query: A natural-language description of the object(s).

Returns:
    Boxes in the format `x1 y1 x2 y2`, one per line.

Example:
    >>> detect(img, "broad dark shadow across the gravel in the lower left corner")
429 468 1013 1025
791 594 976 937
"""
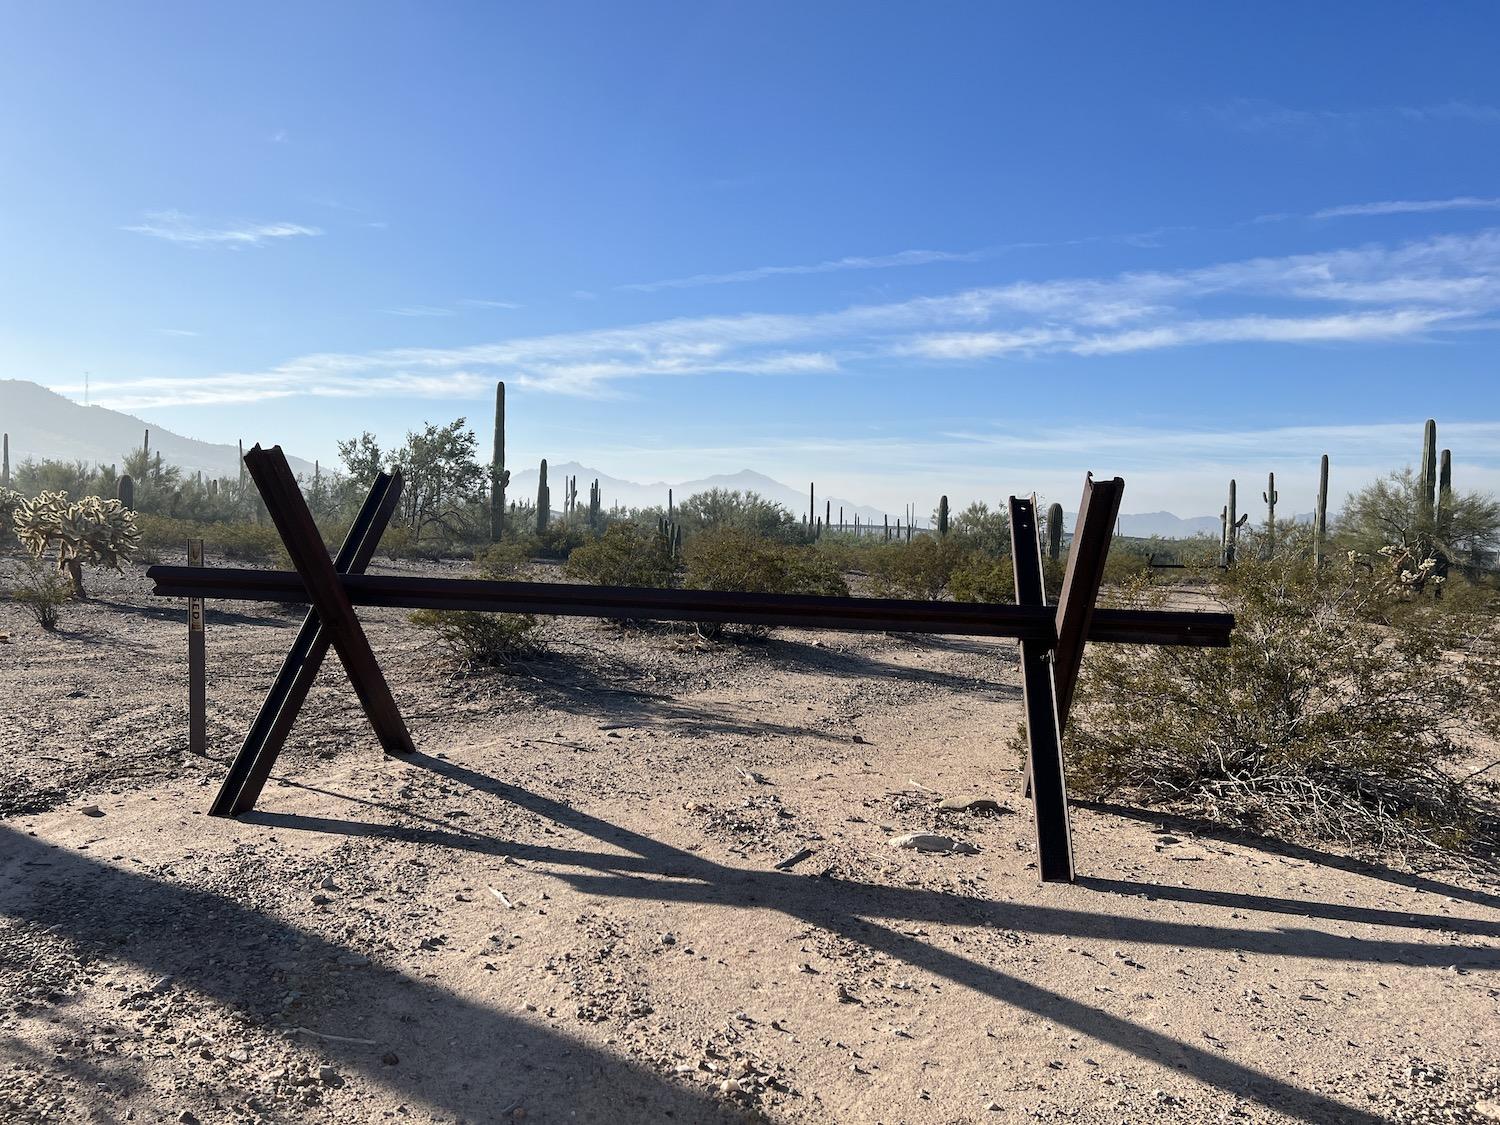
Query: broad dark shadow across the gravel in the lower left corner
0 825 744 1125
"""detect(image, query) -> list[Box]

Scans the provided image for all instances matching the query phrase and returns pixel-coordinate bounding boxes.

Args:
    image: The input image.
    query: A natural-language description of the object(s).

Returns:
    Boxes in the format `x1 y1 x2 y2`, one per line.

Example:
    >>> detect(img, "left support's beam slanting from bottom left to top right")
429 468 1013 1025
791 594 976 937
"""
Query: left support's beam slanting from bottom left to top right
209 473 402 816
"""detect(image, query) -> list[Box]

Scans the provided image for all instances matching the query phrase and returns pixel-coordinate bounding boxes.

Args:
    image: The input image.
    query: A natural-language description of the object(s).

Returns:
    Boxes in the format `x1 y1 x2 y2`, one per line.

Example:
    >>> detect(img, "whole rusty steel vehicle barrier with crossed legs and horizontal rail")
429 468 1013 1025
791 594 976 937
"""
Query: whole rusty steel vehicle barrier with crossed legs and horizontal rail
146 446 1235 882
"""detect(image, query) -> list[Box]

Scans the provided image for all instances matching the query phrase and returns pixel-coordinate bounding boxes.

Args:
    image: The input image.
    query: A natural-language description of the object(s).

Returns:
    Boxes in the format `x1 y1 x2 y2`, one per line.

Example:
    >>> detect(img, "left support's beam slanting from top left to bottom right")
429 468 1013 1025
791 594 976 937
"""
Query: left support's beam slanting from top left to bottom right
245 446 416 755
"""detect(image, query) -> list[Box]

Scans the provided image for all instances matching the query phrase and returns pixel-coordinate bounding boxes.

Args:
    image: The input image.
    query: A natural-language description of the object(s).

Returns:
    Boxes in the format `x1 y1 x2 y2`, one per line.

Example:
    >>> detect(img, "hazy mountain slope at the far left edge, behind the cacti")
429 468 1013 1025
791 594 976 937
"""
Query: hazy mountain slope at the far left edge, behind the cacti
0 380 312 477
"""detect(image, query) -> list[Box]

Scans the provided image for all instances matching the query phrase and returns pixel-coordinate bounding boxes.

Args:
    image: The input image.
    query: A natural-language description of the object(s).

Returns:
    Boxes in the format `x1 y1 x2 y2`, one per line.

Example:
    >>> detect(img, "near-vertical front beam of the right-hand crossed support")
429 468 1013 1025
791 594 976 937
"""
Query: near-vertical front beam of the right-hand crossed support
1010 497 1074 884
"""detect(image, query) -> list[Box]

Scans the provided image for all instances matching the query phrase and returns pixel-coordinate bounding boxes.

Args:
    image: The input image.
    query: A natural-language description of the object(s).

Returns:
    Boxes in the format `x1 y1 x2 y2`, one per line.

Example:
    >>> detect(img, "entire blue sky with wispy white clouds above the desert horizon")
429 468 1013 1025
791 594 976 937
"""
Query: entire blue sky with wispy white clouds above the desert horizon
0 2 1500 515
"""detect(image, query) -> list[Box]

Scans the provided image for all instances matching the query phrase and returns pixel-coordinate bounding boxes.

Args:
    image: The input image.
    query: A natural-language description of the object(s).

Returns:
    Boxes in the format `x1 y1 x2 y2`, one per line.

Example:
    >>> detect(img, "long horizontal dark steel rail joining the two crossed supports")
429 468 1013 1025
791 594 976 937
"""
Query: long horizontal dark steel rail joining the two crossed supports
146 566 1235 648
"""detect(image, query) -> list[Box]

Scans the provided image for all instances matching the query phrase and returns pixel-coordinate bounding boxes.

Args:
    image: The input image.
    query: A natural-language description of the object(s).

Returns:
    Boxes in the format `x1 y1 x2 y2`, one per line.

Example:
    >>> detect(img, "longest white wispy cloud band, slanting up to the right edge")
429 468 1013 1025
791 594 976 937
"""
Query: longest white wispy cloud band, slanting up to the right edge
70 228 1500 410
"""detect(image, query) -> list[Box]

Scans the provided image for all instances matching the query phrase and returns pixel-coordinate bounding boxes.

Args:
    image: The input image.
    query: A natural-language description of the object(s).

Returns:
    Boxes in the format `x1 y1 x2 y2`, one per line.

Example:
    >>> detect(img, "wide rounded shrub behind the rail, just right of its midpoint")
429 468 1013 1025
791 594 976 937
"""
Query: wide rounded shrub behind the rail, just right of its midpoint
683 527 849 636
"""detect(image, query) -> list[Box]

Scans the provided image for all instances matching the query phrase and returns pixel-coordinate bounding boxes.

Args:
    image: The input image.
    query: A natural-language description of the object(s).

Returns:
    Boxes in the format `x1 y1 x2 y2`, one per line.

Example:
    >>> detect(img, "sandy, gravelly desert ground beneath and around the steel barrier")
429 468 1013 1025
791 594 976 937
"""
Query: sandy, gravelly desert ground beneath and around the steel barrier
0 560 1500 1125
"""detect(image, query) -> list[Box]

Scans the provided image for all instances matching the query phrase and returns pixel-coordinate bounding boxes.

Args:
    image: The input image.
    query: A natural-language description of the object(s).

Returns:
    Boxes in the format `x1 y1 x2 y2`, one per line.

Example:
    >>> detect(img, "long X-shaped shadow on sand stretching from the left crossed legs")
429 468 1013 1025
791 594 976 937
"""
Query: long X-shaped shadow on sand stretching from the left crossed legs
246 755 1500 1125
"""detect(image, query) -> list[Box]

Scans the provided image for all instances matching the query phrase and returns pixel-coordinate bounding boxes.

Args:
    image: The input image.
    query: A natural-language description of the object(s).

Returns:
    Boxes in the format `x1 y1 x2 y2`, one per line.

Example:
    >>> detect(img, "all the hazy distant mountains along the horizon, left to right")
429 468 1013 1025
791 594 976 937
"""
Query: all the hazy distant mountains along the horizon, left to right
0 380 1254 539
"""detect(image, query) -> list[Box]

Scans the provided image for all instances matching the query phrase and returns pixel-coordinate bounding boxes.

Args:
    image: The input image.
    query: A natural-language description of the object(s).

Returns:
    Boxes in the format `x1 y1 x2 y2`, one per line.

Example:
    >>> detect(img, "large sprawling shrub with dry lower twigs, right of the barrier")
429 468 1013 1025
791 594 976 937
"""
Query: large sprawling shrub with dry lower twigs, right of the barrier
1067 557 1500 846
